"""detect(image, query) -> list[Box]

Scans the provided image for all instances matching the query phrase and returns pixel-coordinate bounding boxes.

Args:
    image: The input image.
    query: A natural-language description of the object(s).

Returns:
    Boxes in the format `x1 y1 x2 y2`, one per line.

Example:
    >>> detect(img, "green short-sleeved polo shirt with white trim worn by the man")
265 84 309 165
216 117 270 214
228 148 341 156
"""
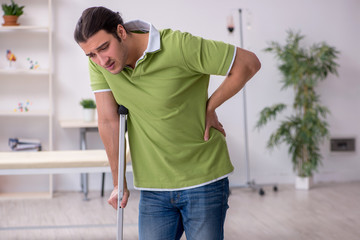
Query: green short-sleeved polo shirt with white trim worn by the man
89 22 235 190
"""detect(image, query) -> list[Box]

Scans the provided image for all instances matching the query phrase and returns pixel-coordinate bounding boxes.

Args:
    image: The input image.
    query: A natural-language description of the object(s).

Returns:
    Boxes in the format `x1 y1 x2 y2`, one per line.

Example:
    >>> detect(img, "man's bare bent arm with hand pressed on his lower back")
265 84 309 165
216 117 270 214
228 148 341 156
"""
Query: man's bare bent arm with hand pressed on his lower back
204 48 261 141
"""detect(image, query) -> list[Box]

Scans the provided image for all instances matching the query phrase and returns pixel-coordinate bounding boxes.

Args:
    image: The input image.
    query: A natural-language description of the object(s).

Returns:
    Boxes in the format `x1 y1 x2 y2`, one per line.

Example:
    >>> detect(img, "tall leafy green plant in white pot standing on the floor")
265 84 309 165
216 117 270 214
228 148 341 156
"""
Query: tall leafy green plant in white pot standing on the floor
256 31 339 189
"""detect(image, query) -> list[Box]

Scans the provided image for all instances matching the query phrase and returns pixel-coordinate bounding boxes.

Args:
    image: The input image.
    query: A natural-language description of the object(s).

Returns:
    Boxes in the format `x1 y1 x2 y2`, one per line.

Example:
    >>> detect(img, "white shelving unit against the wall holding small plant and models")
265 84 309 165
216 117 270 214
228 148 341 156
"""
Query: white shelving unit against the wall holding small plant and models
0 0 53 197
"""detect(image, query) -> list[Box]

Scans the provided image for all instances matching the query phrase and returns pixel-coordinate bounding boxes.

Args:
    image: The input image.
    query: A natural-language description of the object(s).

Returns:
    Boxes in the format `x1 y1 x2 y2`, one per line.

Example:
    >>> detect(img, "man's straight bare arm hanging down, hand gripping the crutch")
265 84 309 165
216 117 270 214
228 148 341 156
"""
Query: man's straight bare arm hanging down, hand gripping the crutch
95 91 130 209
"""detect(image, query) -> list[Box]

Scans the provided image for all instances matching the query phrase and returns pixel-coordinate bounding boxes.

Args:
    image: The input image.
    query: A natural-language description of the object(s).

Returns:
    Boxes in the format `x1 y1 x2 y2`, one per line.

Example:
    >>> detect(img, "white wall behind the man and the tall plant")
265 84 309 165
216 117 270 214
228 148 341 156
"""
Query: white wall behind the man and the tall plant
1 0 360 190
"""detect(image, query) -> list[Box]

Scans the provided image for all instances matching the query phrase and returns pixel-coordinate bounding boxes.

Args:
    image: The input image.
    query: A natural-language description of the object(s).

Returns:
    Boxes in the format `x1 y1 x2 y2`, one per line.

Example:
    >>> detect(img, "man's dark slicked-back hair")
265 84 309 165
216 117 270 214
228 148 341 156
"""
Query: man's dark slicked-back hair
74 7 128 43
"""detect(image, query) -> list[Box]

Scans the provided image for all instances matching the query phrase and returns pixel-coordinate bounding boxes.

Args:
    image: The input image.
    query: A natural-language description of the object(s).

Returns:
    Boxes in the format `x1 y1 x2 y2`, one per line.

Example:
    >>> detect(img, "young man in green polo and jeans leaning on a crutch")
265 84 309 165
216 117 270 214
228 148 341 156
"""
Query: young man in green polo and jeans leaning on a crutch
74 7 260 240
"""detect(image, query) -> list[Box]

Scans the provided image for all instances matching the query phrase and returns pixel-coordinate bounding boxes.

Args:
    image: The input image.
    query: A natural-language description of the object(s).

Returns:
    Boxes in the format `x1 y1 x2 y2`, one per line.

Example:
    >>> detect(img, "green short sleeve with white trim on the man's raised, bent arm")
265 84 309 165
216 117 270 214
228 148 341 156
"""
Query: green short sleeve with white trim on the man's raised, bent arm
181 33 236 76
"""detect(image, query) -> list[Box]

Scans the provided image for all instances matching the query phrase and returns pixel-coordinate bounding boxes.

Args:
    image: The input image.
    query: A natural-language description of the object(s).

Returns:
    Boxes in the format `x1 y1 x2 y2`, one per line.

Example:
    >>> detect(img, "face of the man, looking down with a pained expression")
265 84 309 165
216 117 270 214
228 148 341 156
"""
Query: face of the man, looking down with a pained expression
79 30 128 74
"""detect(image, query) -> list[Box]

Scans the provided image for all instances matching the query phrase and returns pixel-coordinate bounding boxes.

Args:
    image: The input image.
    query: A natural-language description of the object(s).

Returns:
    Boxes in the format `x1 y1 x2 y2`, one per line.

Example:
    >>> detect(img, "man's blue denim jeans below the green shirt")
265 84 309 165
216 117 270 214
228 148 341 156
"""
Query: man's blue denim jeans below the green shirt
139 178 229 240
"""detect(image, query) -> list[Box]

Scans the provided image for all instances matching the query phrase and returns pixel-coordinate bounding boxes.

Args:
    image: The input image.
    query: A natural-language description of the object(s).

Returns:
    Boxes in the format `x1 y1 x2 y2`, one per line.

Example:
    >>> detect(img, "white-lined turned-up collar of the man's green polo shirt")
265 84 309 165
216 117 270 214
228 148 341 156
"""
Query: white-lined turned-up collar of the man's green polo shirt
124 20 160 55
